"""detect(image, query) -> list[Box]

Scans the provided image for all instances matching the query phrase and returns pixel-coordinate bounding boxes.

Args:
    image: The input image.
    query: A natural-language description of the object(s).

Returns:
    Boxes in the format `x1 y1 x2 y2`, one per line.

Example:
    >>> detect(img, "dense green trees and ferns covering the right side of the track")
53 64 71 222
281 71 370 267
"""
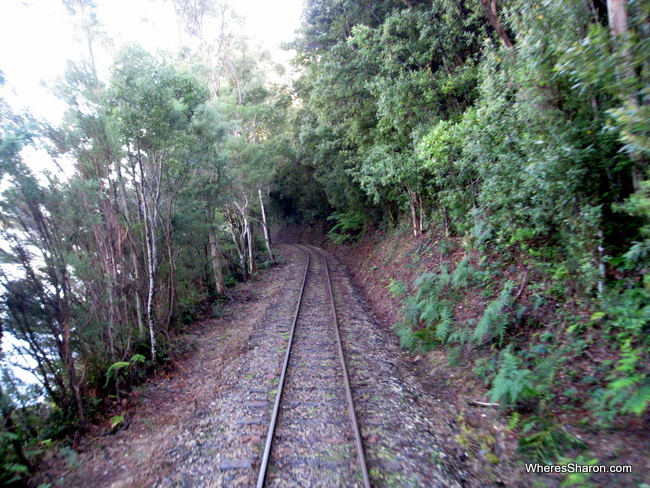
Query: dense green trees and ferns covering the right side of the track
280 0 650 472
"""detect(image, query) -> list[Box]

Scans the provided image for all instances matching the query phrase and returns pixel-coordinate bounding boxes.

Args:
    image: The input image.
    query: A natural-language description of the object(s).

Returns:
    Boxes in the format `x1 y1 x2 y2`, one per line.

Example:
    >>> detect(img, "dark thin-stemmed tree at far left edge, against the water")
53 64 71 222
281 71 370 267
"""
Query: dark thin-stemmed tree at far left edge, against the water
0 96 85 421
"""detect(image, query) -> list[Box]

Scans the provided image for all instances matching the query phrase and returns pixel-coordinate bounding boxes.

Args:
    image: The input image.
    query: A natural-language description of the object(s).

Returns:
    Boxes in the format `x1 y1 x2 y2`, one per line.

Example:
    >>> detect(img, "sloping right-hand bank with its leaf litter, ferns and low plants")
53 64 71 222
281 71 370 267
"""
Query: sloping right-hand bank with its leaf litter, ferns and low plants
312 222 650 486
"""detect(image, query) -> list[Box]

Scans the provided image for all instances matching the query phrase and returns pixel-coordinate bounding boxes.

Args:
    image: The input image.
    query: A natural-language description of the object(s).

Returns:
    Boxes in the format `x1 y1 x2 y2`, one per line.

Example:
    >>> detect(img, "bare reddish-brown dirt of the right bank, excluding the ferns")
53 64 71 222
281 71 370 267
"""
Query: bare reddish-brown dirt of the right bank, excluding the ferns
283 222 650 488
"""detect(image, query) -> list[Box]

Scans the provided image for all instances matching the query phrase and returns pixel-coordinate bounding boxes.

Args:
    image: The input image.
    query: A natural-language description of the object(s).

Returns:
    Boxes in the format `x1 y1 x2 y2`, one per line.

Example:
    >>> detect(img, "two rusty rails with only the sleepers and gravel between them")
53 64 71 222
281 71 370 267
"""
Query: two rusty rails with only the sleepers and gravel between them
257 244 370 488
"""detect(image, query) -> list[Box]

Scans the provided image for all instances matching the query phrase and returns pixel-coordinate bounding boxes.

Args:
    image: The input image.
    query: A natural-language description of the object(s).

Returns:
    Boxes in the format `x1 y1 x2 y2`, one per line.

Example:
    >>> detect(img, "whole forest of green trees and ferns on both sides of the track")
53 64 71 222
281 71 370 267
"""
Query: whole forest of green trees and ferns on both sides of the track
0 0 650 483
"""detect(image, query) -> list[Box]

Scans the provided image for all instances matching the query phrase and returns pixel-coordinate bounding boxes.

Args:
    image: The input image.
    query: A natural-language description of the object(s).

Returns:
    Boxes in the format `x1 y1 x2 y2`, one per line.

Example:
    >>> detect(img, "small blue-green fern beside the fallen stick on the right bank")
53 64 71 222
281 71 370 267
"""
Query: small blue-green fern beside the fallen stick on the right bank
488 346 535 406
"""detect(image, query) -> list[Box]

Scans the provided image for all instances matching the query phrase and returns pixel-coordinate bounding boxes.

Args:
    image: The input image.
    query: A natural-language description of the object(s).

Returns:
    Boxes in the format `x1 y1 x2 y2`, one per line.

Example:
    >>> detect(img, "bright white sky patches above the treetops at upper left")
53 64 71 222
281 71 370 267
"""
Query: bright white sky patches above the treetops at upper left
0 0 303 122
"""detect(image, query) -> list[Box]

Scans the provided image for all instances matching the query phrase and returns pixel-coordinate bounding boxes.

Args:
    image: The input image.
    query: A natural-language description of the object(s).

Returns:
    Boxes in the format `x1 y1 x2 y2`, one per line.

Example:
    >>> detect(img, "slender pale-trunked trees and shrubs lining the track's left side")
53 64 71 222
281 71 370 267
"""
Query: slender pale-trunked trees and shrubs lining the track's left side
0 0 292 484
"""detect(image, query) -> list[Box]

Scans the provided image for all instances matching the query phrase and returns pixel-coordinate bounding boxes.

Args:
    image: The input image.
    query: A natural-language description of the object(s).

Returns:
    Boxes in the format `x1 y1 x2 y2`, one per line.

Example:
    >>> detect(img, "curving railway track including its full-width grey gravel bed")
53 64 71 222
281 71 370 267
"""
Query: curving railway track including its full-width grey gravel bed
155 244 463 488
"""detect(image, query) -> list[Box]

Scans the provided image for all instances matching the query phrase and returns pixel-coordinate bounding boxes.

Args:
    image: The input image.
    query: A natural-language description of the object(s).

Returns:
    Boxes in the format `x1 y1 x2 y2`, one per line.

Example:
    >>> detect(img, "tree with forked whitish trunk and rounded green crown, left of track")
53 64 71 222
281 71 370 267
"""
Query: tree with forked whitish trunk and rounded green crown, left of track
110 46 209 359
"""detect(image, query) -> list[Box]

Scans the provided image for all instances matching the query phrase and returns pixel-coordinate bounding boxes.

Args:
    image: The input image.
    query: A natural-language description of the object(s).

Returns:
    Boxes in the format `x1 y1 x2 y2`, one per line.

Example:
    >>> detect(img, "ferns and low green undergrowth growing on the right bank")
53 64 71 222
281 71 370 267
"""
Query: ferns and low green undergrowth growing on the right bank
389 231 650 470
